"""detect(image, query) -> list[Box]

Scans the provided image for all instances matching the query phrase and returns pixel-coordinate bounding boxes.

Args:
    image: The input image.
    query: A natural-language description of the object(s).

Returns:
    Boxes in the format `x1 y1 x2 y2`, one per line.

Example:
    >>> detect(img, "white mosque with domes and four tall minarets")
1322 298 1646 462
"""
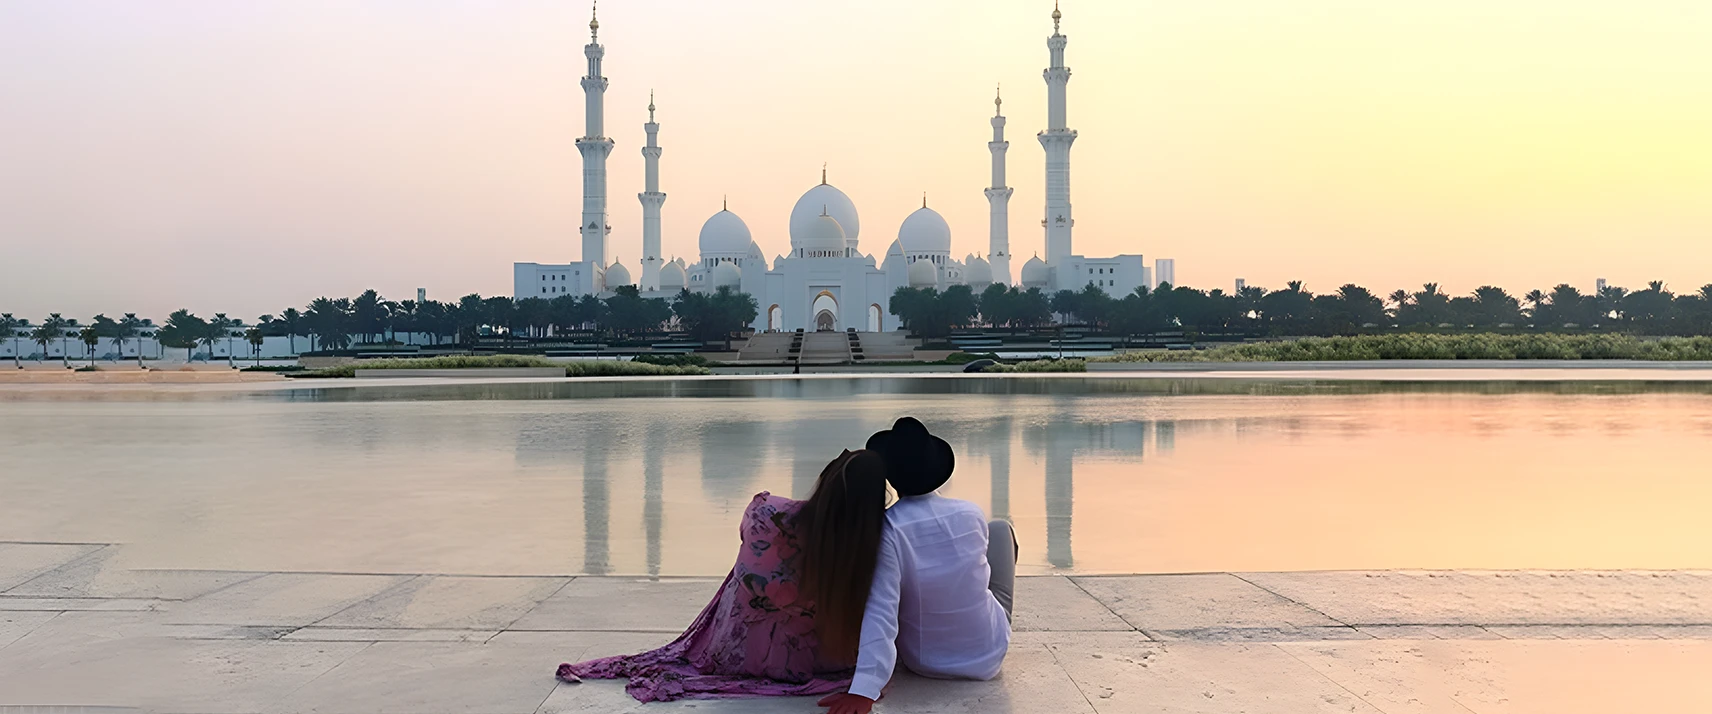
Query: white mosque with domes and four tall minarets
512 7 1171 332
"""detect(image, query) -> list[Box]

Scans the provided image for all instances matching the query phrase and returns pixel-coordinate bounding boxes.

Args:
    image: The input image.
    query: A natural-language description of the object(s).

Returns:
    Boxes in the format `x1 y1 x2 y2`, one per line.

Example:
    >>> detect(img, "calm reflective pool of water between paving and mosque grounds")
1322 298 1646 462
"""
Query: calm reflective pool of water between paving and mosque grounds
0 377 1712 575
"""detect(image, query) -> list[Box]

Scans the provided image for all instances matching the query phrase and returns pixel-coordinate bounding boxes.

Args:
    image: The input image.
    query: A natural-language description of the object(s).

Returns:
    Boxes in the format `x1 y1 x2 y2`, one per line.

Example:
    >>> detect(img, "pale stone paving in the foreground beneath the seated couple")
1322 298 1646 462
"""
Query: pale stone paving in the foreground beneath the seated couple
0 543 1712 714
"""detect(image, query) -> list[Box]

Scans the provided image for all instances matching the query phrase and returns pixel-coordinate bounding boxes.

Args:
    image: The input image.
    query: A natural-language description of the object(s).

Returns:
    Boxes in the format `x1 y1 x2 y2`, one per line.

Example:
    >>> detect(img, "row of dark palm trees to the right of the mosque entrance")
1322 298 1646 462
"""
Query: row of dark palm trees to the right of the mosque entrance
890 283 1712 339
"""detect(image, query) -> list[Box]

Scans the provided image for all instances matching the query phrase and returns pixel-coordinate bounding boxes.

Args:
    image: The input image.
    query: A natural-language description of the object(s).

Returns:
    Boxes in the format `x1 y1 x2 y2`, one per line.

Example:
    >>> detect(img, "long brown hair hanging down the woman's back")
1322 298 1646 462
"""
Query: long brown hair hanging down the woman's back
796 450 885 663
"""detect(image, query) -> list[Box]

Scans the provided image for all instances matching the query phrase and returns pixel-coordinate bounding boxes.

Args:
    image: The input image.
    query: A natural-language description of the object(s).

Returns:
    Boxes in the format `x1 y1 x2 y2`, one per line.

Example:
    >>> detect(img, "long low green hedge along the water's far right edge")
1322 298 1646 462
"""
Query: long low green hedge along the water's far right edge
1094 332 1712 363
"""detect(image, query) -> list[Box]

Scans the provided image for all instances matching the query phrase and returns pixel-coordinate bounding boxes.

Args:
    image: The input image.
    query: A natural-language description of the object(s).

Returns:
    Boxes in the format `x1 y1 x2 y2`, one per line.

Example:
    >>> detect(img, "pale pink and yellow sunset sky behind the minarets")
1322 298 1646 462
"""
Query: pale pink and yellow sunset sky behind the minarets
0 0 1712 320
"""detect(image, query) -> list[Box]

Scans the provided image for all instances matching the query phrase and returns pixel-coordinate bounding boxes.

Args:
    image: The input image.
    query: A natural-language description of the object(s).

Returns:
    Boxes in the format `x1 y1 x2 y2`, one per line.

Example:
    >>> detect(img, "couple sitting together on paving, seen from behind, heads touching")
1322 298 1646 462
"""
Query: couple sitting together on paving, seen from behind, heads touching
558 416 1017 714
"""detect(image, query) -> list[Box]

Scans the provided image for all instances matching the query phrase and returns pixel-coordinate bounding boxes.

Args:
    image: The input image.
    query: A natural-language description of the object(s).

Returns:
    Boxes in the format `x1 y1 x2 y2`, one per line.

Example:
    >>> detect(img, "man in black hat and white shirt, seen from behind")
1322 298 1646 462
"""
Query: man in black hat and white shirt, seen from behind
820 416 1017 714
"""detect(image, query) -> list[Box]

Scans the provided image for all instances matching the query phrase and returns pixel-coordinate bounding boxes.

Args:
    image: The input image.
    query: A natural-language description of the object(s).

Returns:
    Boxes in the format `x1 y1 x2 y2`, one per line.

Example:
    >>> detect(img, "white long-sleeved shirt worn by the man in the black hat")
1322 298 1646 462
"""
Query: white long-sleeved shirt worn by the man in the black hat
849 493 1010 699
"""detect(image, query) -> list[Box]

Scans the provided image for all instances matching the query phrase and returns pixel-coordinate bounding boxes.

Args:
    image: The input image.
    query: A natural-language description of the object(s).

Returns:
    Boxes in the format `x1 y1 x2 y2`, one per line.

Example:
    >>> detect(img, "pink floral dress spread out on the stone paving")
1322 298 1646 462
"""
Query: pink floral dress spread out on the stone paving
558 491 851 702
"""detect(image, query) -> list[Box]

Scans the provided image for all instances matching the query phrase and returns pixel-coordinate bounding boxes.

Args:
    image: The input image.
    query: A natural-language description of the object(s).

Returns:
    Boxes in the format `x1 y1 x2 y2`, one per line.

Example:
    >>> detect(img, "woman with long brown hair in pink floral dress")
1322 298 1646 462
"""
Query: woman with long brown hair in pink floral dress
558 450 887 702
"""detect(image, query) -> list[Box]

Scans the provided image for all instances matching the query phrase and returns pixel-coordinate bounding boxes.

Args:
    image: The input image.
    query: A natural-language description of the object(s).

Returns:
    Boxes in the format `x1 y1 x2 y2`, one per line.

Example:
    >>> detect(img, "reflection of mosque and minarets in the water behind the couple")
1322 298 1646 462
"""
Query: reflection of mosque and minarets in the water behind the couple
517 414 1176 575
